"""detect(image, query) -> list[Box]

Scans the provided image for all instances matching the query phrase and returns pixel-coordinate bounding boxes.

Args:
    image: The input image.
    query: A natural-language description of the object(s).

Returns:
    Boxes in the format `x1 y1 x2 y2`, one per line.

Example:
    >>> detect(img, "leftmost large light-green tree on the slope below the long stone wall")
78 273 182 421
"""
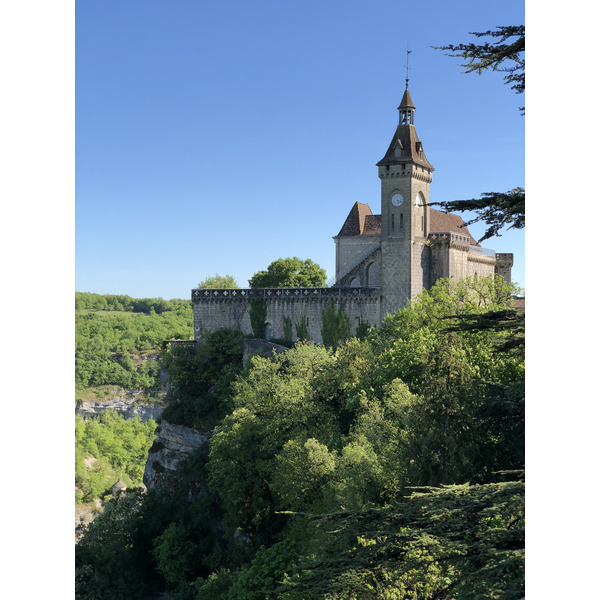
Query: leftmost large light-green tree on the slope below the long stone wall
208 344 336 544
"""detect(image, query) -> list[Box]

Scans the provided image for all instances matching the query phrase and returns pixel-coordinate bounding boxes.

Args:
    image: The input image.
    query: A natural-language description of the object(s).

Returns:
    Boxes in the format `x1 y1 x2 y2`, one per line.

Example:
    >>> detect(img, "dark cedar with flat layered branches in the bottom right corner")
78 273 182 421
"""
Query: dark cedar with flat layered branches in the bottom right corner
276 473 525 600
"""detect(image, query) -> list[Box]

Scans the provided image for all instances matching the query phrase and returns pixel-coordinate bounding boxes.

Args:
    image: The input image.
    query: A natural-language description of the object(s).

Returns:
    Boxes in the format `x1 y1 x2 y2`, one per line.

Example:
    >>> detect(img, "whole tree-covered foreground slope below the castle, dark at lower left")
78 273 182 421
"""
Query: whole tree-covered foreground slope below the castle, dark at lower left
76 278 524 600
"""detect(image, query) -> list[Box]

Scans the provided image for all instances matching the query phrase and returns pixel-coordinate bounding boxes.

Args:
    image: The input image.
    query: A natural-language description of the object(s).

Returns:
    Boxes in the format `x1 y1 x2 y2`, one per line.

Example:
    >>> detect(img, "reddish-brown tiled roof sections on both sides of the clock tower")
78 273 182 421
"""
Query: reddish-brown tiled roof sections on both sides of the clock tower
338 202 479 246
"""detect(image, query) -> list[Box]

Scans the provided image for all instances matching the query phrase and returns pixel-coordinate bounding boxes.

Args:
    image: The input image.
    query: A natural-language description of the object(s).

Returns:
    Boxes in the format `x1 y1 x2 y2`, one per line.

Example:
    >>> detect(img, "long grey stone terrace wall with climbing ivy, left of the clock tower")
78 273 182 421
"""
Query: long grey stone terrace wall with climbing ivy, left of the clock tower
192 287 381 344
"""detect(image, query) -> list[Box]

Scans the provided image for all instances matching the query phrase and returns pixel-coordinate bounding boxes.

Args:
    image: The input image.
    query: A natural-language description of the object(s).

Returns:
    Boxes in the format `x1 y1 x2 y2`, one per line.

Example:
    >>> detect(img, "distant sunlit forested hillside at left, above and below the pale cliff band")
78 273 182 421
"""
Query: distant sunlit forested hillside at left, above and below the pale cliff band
75 292 192 508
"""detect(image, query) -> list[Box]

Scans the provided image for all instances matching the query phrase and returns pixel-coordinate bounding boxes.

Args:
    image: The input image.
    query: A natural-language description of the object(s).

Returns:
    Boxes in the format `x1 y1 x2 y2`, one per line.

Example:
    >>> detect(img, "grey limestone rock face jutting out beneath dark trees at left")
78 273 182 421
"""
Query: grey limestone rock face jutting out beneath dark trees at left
143 421 210 489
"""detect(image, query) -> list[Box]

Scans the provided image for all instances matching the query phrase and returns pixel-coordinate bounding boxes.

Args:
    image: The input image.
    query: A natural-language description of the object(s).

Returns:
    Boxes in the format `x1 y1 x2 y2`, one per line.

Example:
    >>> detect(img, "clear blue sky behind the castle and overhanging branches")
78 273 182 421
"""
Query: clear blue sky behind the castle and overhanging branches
75 0 525 299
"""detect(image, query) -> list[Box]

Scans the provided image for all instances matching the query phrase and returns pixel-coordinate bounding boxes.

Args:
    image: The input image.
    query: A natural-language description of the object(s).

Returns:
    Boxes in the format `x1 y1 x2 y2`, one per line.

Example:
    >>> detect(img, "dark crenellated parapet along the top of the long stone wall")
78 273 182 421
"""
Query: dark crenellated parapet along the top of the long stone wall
192 287 380 304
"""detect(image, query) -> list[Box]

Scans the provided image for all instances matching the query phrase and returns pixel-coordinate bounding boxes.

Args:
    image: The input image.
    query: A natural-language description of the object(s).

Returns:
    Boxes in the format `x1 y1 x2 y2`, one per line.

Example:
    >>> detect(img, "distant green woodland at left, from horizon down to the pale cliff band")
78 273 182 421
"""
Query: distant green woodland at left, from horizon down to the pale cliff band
75 292 193 390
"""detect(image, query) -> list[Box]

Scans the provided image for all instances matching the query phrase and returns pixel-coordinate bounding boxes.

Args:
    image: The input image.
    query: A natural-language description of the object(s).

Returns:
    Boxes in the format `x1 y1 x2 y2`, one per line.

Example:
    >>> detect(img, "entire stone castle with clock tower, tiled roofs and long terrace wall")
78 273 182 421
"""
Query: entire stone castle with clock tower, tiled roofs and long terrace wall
192 80 513 343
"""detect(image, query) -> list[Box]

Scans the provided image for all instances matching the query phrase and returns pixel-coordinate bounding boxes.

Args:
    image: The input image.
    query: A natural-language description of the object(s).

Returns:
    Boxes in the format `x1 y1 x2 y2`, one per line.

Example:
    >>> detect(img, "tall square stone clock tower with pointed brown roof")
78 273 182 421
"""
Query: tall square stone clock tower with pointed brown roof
377 84 434 317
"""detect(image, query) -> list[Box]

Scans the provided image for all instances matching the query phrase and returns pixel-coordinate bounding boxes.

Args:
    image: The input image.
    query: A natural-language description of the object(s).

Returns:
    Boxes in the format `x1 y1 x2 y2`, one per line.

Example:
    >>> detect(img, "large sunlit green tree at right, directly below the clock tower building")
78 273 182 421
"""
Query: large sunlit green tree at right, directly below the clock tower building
373 277 524 485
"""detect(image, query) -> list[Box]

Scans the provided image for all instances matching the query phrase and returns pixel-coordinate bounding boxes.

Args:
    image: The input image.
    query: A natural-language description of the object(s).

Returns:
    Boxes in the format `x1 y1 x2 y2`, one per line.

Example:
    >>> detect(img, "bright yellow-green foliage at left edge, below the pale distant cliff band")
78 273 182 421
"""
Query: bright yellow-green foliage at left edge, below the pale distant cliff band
75 410 156 502
